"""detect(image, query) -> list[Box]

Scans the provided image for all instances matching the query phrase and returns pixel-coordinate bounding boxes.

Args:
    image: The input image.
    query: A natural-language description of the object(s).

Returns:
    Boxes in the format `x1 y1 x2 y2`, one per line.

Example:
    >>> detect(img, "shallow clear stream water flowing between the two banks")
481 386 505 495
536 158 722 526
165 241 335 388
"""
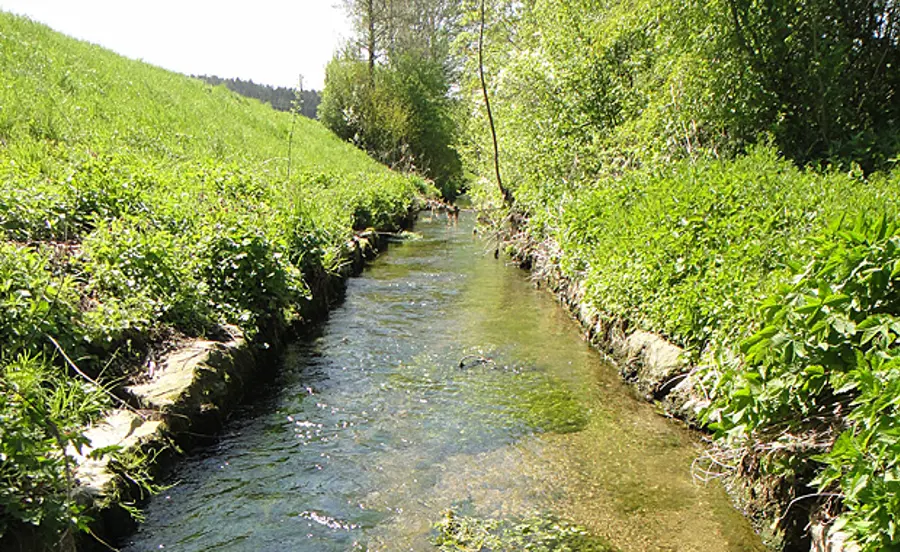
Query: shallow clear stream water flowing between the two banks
125 213 763 552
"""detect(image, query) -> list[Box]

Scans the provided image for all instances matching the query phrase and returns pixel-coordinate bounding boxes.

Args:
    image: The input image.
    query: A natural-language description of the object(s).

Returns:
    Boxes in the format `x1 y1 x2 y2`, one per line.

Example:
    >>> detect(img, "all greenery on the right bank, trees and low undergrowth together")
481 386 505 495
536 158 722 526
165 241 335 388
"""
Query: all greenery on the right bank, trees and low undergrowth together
456 0 900 551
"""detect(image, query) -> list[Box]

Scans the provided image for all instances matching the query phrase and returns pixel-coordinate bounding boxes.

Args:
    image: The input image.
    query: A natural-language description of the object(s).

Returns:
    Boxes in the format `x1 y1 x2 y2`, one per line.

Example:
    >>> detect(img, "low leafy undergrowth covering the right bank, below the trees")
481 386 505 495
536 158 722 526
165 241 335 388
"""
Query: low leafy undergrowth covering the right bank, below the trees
478 147 900 550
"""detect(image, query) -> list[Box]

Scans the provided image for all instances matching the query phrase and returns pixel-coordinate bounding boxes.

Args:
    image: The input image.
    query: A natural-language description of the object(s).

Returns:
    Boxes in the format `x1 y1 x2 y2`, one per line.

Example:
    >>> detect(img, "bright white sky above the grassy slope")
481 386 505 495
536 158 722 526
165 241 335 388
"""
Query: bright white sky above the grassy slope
0 0 350 90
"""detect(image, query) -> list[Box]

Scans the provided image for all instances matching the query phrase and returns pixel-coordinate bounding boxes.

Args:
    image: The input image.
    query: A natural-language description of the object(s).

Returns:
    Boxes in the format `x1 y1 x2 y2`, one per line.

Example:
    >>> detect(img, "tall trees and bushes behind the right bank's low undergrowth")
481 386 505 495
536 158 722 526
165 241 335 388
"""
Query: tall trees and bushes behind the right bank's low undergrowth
459 0 900 197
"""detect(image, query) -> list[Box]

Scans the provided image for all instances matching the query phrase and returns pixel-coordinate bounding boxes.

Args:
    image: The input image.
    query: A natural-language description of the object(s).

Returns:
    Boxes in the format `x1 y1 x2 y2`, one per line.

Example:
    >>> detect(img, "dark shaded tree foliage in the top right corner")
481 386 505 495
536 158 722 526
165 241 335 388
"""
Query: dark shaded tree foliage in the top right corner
726 0 900 169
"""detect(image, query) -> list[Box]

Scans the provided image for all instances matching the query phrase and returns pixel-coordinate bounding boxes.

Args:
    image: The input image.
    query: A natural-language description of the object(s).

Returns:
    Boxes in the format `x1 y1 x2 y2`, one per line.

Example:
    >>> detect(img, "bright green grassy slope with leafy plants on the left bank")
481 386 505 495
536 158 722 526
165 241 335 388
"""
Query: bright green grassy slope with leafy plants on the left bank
0 14 425 543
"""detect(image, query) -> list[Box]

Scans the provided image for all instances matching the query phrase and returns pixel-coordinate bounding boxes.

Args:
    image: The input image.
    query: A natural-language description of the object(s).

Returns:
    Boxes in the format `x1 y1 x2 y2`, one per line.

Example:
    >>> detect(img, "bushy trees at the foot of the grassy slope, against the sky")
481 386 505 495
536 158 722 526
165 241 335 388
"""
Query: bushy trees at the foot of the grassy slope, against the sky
319 0 463 199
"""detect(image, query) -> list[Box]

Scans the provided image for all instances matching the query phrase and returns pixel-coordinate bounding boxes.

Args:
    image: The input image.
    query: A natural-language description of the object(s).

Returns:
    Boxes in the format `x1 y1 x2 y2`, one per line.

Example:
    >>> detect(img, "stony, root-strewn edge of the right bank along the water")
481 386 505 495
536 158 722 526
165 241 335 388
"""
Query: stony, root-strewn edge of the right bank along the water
500 232 858 552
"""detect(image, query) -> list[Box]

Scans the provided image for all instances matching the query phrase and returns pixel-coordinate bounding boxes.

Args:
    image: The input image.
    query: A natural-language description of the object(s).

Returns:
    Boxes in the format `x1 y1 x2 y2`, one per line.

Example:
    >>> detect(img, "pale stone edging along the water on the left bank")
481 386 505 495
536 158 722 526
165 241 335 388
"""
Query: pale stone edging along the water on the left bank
69 224 406 550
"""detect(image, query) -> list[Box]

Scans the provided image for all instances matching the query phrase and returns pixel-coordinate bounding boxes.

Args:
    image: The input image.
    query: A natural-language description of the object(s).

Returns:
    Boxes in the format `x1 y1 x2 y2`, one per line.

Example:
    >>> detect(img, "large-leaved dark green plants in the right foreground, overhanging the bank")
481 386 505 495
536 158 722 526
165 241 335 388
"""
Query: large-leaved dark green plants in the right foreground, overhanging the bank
707 215 900 551
